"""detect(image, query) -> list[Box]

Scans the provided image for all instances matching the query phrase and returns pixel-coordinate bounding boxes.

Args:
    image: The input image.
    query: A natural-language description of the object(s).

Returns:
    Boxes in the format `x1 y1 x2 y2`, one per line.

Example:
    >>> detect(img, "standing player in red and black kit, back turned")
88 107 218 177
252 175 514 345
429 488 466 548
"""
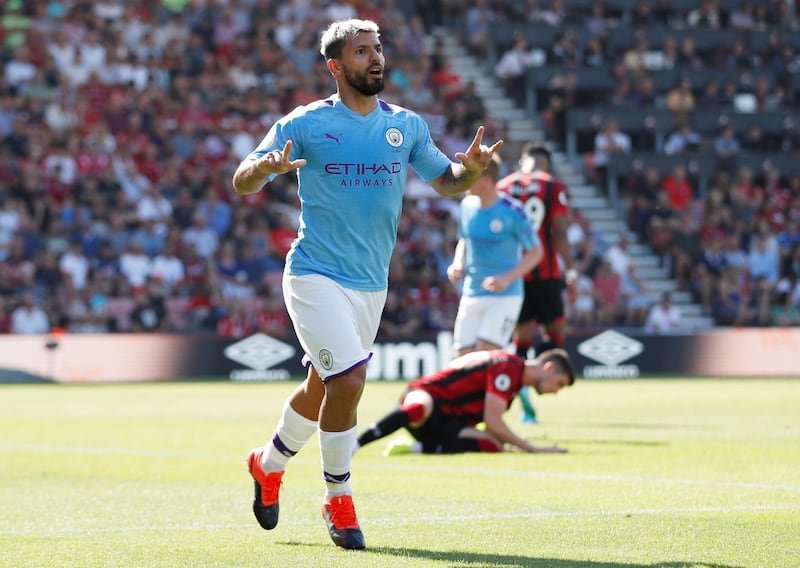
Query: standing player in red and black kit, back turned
497 142 578 422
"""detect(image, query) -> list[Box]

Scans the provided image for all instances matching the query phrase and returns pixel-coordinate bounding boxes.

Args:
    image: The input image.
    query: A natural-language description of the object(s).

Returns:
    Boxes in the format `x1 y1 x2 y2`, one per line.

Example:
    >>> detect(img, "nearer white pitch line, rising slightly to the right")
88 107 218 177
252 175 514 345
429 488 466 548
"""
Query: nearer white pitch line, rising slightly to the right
0 505 800 536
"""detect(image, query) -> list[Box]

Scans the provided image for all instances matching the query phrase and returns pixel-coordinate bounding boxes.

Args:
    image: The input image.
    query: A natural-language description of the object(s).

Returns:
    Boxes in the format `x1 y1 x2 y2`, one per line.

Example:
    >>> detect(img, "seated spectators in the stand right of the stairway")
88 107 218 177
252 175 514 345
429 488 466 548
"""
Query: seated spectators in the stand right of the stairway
488 0 800 326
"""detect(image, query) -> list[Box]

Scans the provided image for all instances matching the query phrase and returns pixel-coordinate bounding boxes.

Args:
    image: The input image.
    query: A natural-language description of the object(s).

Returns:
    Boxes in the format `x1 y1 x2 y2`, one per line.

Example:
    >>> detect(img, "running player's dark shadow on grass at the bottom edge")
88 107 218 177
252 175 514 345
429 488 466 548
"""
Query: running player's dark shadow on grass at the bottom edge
367 547 743 568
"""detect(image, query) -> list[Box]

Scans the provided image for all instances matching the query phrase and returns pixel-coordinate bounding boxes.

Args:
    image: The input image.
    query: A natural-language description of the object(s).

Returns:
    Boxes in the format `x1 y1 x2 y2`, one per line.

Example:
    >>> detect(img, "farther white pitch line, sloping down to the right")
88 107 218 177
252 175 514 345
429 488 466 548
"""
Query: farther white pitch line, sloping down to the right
0 441 800 493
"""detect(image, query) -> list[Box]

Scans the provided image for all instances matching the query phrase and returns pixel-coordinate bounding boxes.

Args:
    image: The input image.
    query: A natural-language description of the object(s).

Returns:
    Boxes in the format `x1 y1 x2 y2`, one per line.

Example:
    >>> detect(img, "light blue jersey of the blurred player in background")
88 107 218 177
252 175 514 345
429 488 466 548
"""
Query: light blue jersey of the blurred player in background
458 195 539 296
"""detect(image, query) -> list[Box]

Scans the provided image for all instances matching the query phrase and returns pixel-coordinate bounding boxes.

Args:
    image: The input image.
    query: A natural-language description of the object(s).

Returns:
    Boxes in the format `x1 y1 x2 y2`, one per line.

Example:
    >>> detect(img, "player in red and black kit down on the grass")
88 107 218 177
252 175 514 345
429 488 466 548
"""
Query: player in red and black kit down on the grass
353 349 575 455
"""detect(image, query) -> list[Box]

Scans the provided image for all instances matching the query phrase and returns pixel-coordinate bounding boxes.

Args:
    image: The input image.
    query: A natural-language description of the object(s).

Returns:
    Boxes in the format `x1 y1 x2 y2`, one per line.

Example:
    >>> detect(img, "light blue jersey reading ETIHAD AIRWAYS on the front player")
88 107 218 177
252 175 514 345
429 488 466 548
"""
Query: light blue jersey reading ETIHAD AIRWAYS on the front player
250 95 450 291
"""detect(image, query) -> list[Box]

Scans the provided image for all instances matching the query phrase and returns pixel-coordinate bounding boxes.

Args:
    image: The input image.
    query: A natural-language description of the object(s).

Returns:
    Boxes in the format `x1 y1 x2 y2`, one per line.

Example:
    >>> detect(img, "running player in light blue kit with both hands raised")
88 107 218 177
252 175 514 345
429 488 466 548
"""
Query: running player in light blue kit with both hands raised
233 20 503 549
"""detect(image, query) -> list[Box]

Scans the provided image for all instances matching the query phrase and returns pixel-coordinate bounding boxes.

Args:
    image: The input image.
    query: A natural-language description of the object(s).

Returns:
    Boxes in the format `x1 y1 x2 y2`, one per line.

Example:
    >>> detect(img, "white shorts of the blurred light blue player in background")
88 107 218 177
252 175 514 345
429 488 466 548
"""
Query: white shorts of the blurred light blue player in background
453 296 522 350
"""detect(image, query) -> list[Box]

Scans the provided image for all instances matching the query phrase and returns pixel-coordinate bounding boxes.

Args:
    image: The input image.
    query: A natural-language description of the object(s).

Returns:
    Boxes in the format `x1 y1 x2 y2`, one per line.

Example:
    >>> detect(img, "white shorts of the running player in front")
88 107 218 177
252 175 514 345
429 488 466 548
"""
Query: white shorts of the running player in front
283 274 386 382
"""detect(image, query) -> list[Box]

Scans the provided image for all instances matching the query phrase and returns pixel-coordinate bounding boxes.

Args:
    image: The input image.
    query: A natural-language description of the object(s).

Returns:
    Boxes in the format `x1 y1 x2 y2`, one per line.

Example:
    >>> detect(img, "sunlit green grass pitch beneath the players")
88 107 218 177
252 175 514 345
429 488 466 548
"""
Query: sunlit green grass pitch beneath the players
0 379 800 568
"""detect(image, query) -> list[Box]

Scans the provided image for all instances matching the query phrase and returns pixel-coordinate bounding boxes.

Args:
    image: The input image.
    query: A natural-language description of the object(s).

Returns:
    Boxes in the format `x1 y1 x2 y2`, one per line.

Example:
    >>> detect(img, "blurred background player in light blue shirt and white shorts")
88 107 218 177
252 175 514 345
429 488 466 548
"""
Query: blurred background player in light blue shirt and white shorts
447 151 542 356
